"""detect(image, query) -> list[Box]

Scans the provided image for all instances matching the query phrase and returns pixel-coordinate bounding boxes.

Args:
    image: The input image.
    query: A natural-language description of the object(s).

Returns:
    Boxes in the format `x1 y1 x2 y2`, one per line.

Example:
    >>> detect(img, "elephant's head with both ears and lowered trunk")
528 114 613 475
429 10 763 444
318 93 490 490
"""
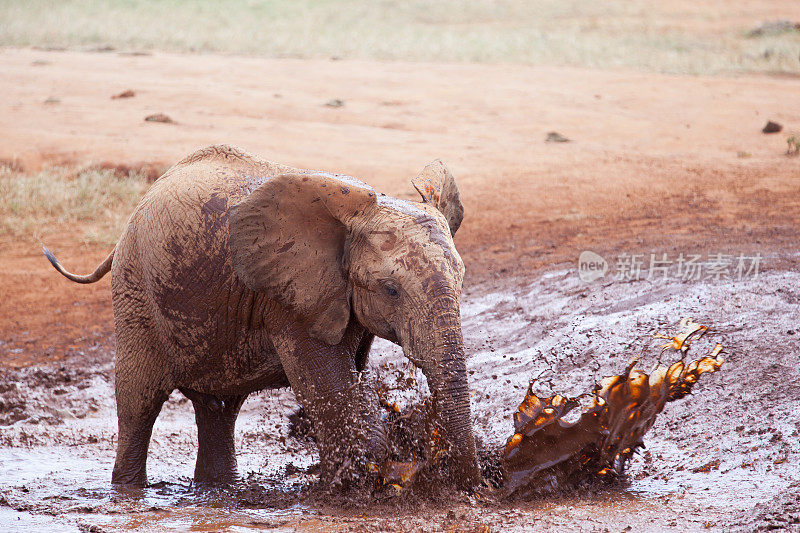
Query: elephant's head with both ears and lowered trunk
230 161 479 486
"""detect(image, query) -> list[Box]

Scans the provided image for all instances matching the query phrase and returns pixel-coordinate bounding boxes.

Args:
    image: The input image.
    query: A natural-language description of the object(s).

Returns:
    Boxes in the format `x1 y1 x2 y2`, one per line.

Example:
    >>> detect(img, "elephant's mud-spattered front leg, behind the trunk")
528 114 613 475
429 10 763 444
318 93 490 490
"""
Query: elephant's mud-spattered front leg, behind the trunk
281 328 386 486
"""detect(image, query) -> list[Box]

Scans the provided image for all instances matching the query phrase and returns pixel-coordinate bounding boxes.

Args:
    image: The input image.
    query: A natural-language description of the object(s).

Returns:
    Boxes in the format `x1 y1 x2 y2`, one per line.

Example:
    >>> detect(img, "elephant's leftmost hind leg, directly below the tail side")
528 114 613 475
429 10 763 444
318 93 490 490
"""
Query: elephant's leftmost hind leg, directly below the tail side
111 387 169 486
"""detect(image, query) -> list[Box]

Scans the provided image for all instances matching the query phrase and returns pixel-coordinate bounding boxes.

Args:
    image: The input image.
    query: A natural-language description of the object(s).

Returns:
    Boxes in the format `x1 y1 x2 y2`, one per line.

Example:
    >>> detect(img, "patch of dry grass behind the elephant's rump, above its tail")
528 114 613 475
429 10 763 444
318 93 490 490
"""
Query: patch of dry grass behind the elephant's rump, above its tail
0 166 148 244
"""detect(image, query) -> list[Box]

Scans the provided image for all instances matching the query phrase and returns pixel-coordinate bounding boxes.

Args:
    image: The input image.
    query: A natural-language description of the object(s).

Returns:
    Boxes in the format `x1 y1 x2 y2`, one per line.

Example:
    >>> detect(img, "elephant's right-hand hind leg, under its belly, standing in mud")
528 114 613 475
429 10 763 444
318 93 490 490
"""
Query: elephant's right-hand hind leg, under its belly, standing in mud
187 389 247 483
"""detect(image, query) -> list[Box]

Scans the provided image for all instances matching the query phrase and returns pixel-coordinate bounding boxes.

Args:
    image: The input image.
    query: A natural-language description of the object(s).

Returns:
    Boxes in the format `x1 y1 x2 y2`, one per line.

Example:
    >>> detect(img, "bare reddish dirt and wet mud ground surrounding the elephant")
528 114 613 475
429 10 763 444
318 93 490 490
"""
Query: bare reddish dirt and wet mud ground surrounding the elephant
0 49 800 531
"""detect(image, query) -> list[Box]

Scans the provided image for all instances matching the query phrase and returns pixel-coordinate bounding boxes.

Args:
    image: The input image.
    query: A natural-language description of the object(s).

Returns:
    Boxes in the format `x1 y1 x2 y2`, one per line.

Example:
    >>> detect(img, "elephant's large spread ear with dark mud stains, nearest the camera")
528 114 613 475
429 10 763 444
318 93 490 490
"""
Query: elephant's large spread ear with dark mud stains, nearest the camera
229 173 376 345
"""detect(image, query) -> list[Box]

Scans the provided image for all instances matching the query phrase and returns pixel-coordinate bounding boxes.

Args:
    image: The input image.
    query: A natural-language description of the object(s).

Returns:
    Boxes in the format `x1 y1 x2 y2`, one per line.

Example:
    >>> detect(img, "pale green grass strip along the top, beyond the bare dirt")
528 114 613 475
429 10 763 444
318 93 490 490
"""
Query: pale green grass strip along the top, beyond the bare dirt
0 0 800 74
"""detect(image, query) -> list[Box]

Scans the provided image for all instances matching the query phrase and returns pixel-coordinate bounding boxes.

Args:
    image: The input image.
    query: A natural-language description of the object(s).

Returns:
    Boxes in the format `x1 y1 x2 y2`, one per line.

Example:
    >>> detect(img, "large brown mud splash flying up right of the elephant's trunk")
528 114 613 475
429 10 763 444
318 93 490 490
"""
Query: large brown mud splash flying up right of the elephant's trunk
500 319 724 497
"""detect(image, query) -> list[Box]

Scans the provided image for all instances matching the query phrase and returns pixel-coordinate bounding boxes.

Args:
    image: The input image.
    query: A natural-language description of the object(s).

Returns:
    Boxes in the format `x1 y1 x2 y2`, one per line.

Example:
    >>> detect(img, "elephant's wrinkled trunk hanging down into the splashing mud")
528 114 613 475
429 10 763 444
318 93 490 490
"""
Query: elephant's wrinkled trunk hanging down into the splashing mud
418 299 480 488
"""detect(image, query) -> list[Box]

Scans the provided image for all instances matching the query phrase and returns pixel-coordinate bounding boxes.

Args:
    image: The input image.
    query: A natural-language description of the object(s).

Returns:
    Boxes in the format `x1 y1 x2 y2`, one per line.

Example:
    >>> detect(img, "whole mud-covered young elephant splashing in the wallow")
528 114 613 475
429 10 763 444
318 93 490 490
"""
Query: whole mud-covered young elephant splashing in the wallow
45 146 479 486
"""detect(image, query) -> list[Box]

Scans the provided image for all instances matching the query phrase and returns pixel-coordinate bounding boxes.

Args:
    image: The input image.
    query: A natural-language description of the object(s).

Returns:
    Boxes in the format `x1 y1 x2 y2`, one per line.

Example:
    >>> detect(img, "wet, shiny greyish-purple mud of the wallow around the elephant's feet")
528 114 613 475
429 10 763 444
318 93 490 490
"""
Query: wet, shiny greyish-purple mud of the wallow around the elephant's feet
0 272 800 531
